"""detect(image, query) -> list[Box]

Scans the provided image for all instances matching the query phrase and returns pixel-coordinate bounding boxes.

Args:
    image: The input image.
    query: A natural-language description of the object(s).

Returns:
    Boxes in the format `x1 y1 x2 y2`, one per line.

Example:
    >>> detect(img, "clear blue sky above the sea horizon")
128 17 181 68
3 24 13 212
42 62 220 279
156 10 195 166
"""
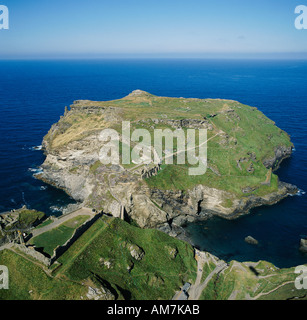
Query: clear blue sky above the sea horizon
0 0 307 58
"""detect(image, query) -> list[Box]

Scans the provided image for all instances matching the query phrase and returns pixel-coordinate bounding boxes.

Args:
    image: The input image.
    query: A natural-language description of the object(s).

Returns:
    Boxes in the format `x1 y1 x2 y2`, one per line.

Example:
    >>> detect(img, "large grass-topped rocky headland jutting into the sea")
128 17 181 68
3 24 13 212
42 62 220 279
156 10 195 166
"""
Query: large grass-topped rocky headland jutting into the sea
37 90 296 227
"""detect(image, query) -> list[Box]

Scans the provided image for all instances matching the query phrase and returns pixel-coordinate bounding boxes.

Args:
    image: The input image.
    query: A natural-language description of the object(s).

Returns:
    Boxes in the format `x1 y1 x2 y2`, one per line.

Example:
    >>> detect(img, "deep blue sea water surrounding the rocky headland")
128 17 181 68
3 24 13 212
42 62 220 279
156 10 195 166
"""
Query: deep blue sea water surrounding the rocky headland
0 59 307 267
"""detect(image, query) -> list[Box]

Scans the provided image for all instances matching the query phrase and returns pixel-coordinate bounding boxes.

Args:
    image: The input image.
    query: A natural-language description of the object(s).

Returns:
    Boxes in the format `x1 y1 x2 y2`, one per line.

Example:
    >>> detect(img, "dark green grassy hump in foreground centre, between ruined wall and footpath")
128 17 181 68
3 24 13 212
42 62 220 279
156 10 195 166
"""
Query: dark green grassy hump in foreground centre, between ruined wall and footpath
59 219 196 299
